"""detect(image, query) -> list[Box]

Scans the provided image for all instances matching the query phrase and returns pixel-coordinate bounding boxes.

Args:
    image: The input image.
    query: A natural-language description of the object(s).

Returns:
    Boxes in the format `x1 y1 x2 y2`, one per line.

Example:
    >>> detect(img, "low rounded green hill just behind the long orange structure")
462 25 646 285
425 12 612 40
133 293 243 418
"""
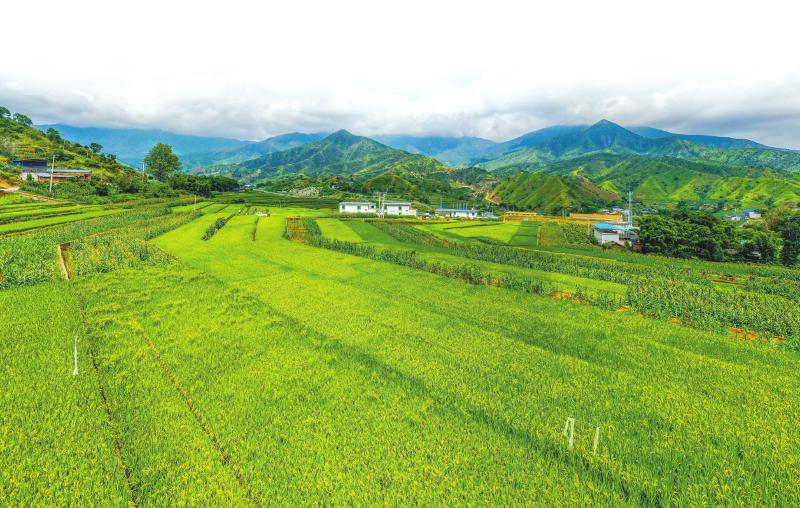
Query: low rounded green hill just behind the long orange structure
494 173 621 215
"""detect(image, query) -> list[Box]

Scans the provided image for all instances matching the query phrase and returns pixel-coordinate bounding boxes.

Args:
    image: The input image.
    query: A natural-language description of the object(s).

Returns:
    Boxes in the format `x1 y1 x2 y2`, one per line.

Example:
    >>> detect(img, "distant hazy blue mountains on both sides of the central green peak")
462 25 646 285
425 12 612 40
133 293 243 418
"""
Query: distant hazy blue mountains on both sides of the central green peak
37 121 792 171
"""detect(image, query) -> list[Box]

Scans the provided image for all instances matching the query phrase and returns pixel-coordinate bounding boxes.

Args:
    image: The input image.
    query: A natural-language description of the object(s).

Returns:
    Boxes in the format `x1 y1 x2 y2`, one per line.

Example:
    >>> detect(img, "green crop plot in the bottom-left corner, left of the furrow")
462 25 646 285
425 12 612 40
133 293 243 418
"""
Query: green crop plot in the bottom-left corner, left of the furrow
0 282 130 506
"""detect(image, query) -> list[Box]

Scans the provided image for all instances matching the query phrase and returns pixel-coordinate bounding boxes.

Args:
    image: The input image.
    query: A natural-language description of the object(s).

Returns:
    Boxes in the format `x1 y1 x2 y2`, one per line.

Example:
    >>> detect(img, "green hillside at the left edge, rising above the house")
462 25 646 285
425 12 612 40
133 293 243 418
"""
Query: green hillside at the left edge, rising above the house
0 118 136 180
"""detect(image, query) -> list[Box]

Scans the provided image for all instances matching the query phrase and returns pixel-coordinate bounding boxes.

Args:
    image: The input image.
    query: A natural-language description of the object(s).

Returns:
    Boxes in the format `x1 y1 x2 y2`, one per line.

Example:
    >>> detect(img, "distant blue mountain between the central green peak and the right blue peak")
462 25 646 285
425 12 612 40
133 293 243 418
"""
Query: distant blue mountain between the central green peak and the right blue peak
372 135 499 166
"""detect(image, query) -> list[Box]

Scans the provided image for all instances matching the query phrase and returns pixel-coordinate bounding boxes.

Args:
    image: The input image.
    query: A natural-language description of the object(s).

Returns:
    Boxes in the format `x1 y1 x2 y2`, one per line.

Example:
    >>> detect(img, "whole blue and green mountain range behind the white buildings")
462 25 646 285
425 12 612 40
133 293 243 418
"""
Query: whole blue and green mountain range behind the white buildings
31 120 800 213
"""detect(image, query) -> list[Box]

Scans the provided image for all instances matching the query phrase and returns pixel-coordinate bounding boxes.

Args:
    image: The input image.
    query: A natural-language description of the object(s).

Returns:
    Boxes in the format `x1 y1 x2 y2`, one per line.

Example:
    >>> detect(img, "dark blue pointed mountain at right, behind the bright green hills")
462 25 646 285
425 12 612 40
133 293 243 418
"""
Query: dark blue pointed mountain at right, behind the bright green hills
482 120 800 174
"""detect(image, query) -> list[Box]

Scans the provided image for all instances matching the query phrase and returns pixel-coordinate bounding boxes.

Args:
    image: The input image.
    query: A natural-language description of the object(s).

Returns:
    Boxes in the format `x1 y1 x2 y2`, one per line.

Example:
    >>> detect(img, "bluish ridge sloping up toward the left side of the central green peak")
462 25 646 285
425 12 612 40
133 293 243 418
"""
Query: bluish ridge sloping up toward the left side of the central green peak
181 132 329 169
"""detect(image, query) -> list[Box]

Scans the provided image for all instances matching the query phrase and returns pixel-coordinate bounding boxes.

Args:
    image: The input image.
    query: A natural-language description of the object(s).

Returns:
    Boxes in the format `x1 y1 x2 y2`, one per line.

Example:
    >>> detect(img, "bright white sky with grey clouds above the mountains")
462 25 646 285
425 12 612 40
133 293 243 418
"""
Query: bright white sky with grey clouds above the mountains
0 0 800 149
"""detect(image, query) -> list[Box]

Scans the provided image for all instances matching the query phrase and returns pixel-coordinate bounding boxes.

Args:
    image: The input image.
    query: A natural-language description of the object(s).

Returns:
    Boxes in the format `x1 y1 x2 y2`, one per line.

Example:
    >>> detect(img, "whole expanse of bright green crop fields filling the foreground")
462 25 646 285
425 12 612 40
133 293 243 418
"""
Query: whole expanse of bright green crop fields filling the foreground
0 196 800 506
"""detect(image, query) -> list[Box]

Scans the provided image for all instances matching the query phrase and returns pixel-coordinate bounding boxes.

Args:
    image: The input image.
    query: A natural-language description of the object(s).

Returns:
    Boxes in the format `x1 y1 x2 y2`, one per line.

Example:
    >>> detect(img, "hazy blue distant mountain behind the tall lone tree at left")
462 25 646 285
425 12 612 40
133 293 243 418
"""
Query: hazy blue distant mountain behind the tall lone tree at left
36 124 250 166
